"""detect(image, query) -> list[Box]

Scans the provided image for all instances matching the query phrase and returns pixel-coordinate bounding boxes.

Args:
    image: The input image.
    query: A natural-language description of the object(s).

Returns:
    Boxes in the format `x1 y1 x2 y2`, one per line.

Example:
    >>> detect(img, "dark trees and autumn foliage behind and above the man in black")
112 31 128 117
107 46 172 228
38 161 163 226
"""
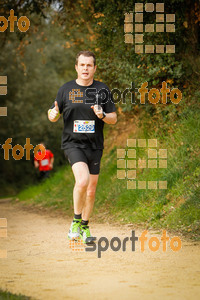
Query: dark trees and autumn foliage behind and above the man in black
0 0 200 194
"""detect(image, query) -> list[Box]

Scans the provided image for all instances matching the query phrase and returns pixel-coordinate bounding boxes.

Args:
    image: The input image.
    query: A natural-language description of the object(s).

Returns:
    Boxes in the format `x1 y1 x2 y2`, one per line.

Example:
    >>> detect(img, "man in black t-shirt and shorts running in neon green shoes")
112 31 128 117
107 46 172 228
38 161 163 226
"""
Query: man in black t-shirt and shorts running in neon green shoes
48 51 117 243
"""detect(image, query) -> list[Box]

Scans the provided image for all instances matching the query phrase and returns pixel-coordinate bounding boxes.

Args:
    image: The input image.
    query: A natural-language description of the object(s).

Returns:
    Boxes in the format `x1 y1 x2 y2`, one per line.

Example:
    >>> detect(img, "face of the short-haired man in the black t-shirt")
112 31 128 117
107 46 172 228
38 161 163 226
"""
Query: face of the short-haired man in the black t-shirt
75 55 96 82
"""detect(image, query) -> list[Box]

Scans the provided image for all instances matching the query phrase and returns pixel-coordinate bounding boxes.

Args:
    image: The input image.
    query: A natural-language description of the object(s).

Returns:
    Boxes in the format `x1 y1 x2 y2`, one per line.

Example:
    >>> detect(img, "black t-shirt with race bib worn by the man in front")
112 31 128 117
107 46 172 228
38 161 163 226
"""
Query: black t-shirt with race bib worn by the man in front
51 80 116 149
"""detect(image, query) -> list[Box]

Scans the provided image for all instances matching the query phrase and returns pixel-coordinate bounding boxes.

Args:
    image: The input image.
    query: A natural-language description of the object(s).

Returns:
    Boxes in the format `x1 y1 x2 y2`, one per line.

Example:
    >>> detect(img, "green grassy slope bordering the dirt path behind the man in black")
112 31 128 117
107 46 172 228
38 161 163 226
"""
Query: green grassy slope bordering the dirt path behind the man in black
18 97 200 238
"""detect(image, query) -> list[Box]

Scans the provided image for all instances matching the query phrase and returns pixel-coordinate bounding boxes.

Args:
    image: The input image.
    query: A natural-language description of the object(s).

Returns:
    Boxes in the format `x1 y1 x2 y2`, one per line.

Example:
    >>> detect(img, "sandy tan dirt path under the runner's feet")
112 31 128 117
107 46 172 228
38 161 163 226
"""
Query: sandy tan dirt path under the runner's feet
0 202 200 300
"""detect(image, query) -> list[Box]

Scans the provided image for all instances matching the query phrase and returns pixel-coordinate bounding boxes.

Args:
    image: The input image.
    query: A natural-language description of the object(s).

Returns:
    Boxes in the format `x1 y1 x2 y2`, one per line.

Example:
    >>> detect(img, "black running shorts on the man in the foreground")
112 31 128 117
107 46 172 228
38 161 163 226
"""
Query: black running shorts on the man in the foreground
64 147 103 175
